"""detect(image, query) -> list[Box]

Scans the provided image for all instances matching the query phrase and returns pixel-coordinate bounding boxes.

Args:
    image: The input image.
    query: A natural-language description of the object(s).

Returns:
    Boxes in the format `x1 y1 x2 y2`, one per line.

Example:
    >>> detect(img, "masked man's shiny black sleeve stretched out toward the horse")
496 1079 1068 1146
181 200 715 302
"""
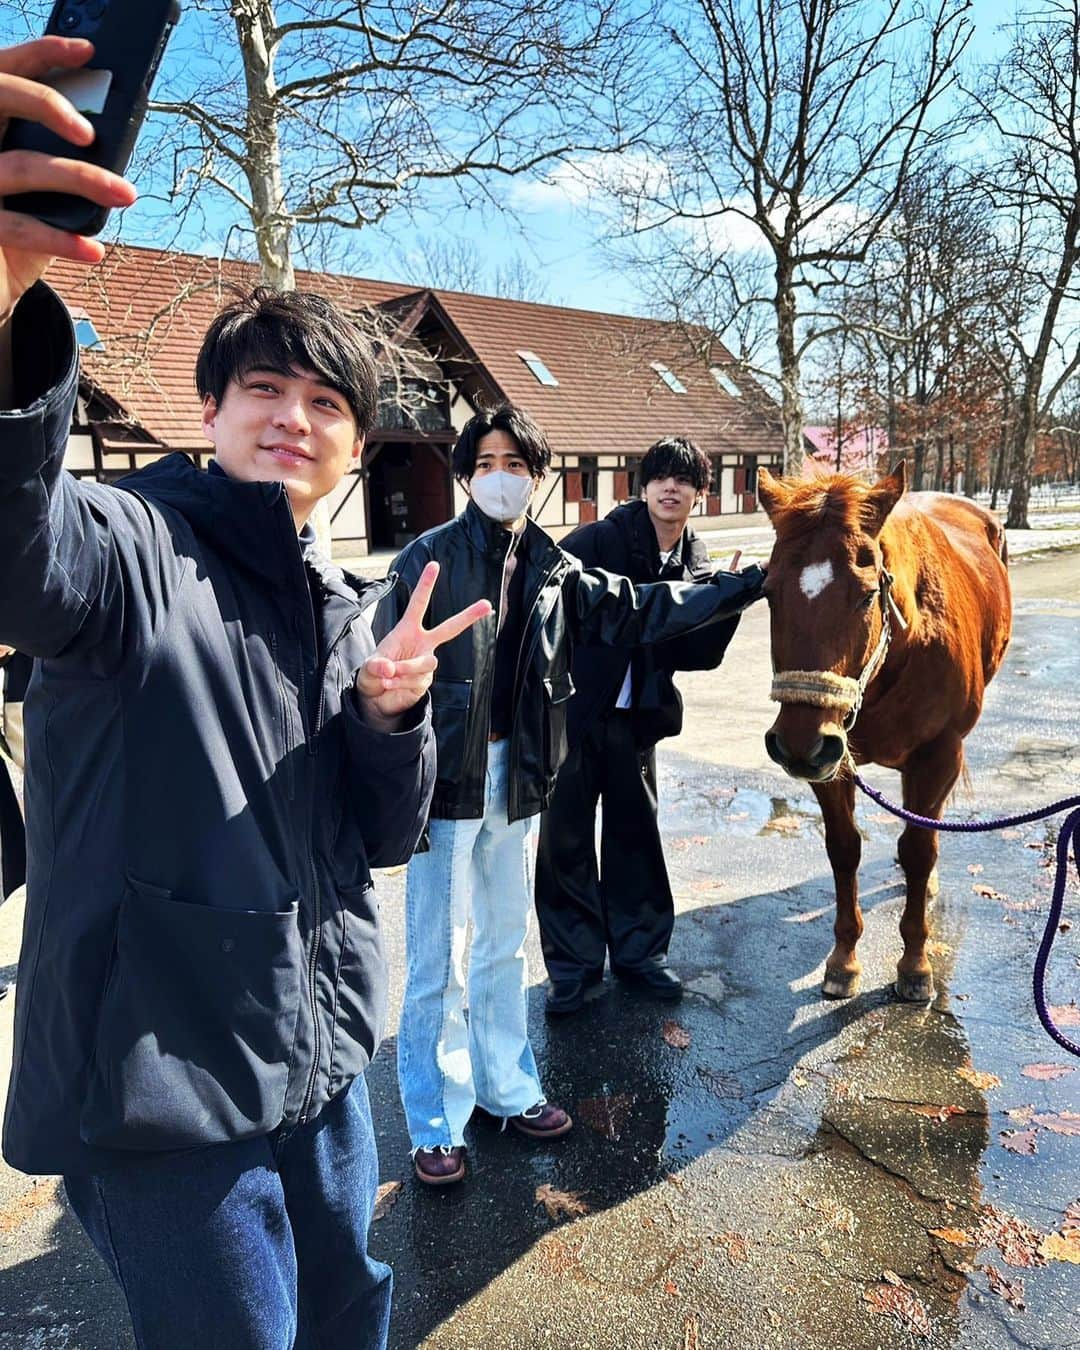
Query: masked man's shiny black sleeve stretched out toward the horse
567 556 765 647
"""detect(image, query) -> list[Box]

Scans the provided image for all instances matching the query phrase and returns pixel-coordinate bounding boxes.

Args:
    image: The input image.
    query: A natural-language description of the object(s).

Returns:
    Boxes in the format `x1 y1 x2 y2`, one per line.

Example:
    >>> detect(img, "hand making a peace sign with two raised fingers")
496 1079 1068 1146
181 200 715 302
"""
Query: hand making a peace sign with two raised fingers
356 563 491 729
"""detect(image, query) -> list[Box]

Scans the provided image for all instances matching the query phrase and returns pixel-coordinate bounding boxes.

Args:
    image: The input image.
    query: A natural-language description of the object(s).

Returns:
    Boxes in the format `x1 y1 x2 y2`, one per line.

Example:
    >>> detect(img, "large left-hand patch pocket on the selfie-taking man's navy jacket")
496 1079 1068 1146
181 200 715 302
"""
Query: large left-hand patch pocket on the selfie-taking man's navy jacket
81 879 304 1149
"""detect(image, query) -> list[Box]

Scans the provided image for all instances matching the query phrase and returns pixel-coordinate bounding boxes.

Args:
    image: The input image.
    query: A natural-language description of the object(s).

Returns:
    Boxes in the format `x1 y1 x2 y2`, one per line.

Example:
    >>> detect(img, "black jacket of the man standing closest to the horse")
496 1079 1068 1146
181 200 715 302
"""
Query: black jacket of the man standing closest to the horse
562 501 757 749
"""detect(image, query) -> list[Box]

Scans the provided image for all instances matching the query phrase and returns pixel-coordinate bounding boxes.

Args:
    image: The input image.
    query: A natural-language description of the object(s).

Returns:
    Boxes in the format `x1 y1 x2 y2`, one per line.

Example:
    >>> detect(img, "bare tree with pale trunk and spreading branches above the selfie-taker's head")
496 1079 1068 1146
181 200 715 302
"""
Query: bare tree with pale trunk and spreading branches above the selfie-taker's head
0 0 645 286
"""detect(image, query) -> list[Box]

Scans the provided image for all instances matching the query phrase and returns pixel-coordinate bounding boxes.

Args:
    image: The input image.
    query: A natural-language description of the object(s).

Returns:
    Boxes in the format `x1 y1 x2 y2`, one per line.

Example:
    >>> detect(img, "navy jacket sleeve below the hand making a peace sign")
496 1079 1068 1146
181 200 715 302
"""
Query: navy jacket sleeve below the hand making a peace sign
343 693 435 867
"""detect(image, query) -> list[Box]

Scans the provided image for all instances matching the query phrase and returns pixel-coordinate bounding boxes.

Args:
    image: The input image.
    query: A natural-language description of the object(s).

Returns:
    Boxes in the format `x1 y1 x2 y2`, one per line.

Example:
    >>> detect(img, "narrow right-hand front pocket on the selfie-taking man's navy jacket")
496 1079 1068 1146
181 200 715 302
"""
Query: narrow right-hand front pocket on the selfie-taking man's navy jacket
328 882 387 1096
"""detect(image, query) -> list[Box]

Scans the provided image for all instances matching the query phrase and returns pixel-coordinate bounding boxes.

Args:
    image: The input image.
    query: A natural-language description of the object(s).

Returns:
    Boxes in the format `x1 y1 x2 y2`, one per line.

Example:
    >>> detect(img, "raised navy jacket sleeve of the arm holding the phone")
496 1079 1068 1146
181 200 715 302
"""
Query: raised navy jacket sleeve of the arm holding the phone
0 282 182 674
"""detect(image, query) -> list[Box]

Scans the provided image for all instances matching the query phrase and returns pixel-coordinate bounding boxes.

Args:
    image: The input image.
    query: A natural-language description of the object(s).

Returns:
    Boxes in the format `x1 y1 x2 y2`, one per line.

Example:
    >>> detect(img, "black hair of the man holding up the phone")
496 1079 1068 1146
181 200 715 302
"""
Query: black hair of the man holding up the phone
194 286 379 436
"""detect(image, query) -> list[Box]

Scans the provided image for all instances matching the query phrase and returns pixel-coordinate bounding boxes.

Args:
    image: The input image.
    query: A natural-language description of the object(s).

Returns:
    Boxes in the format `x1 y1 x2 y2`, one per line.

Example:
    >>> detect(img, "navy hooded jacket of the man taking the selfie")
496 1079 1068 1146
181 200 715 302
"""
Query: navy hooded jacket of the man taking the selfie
0 285 433 1172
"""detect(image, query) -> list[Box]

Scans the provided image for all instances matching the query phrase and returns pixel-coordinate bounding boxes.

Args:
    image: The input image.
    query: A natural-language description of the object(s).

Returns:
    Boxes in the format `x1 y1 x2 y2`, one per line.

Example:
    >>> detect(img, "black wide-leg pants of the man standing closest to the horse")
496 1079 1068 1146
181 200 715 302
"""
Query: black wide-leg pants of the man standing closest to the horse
536 710 675 980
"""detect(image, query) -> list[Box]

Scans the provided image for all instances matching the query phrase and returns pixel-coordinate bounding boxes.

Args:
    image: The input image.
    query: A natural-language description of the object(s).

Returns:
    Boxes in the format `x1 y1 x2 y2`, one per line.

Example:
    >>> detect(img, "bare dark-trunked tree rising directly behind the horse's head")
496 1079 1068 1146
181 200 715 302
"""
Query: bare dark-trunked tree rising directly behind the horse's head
602 0 971 473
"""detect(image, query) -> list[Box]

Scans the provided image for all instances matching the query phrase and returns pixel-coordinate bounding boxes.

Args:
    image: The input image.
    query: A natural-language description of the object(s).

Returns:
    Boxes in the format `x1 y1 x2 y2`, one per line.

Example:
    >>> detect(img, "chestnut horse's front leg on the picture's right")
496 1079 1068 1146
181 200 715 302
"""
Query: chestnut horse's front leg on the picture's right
896 733 964 1003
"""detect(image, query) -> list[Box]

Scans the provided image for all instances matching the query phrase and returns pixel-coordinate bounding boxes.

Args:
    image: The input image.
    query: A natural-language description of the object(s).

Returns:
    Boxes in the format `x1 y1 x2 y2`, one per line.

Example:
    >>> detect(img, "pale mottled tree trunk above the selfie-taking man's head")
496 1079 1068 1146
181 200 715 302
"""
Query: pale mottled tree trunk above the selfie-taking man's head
232 0 296 290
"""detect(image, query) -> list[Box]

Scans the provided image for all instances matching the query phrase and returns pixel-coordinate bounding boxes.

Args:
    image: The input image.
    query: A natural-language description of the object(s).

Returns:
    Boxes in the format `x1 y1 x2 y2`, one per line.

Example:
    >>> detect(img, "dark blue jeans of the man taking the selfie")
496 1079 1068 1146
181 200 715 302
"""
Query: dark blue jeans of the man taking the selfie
63 1077 393 1350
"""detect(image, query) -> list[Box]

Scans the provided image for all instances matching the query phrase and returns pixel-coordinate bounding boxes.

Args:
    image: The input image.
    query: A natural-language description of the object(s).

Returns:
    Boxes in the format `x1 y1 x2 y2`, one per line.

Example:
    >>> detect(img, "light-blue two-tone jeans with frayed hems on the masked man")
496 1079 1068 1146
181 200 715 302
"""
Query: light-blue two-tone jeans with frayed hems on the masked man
397 741 544 1150
